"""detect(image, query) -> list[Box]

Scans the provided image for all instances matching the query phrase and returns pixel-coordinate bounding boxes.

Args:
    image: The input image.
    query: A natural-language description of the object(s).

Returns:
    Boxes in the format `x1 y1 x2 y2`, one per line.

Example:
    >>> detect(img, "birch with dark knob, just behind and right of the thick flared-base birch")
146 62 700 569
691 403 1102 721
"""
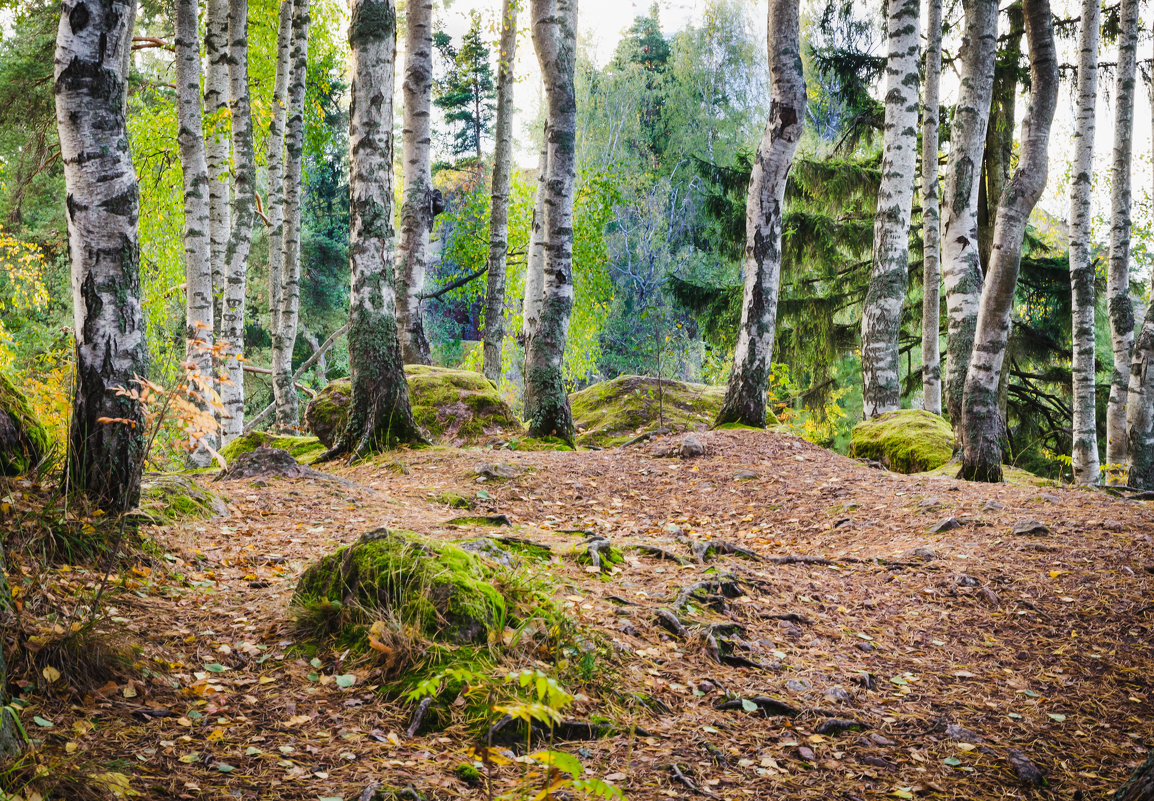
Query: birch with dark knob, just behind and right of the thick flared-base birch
397 0 433 365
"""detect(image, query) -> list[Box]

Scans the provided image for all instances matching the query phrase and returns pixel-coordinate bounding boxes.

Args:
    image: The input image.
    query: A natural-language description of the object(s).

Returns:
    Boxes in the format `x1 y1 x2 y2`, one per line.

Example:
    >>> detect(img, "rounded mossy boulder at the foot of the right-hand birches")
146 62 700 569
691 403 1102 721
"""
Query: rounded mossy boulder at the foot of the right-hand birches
849 409 953 473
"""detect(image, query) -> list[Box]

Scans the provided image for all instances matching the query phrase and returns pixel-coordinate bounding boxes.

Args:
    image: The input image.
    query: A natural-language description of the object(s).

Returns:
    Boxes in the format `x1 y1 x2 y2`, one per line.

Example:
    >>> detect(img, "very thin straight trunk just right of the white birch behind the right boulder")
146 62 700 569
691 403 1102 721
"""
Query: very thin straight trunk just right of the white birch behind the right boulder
922 0 942 414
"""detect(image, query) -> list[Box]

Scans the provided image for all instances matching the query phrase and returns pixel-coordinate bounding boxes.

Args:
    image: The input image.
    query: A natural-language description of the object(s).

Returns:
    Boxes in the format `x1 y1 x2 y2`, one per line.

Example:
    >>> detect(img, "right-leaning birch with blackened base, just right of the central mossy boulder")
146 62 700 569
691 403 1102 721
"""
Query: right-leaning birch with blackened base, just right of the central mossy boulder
715 0 805 428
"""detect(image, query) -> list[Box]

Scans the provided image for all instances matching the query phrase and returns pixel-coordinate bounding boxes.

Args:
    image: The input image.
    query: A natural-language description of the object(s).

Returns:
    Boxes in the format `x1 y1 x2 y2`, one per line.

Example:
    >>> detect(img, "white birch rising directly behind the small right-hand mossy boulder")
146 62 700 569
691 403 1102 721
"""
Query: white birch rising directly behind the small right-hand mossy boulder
862 0 921 419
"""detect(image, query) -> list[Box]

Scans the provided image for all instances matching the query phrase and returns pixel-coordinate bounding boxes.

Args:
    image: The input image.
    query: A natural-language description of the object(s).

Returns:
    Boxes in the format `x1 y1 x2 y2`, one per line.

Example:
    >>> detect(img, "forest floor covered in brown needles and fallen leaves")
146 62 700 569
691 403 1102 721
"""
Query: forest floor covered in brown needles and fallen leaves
6 431 1154 801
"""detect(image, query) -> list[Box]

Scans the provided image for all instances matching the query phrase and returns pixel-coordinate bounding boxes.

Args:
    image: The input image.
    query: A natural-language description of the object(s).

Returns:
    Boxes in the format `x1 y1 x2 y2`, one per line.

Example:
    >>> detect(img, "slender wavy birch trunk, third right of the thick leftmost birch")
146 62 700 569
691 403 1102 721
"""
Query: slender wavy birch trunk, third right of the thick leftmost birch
220 0 256 444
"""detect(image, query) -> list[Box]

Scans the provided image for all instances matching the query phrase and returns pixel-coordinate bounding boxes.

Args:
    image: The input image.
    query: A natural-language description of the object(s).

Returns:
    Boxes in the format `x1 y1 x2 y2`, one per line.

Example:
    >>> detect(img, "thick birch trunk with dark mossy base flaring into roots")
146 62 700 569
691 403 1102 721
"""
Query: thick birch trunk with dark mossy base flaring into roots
325 0 422 458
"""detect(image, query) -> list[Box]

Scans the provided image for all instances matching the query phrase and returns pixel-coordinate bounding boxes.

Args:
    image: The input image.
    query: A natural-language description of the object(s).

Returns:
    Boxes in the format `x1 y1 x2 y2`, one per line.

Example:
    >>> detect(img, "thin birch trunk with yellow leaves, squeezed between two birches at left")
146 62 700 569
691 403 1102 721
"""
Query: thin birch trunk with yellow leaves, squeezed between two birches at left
204 0 232 338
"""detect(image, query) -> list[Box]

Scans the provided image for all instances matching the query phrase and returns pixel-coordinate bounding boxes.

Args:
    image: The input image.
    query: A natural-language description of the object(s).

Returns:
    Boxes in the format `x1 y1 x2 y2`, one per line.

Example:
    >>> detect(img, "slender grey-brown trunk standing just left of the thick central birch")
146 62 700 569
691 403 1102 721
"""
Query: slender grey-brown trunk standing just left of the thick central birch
484 0 517 385
